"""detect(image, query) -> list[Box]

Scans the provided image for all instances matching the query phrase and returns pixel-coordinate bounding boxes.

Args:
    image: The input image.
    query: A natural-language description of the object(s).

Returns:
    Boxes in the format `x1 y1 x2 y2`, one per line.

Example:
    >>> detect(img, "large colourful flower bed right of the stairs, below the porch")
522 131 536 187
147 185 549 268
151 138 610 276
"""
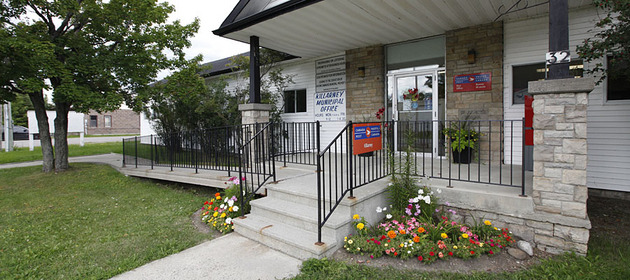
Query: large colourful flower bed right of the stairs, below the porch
344 187 514 263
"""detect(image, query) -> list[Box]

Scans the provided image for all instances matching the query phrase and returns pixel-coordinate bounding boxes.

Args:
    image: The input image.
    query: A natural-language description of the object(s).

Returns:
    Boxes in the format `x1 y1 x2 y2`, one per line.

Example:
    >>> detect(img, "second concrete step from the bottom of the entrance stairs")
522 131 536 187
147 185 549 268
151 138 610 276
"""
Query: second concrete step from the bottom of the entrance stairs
251 196 352 239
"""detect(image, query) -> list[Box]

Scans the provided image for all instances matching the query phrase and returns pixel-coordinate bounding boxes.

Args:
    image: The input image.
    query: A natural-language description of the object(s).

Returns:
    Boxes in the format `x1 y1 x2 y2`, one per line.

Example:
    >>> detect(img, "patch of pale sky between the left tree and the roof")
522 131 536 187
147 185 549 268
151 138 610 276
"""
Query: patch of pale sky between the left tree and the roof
160 0 249 78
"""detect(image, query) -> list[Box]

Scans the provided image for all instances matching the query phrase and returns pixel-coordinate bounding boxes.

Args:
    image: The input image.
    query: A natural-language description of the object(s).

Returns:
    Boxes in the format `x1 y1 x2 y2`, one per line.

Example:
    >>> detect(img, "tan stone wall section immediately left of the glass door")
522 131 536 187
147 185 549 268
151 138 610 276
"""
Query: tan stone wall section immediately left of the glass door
346 45 385 122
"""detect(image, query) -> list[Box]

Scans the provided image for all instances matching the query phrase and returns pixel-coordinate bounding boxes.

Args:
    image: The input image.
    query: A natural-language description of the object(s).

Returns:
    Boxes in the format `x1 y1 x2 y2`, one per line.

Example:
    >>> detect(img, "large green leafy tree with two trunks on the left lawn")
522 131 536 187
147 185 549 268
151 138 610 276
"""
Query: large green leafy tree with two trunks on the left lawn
0 0 199 172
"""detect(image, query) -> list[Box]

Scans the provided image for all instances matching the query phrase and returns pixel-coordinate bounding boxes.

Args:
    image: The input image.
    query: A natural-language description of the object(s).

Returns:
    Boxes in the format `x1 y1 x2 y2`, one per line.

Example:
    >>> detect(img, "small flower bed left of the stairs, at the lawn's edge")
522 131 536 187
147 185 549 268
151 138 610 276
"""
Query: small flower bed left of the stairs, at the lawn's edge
201 177 240 234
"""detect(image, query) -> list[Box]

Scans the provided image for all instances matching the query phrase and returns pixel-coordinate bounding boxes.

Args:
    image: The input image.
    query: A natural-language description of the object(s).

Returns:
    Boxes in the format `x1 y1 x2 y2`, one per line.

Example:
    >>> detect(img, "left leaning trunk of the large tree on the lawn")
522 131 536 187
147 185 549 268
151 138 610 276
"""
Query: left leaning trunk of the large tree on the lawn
28 91 55 172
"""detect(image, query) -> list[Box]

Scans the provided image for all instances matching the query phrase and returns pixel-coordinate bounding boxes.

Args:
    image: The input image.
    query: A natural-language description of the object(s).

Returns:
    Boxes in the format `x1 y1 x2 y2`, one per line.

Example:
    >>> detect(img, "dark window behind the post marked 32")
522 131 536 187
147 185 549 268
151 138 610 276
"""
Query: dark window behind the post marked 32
512 60 584 104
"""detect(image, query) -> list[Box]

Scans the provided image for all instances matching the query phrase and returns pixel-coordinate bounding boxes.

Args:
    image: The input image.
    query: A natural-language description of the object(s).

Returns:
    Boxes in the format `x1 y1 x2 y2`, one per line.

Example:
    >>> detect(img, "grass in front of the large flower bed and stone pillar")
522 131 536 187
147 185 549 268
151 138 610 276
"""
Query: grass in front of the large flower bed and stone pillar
294 198 630 279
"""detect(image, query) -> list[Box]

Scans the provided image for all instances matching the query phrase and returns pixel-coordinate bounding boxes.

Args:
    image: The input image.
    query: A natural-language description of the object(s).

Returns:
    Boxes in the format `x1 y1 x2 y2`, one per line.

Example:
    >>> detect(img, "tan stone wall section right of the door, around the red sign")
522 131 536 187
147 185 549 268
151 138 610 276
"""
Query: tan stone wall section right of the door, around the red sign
446 22 503 162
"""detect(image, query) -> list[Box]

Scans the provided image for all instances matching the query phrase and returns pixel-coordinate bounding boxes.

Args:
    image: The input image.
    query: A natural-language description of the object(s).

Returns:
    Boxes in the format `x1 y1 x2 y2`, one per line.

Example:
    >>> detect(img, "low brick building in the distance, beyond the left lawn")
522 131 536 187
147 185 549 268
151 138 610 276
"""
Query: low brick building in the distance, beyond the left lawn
85 109 140 135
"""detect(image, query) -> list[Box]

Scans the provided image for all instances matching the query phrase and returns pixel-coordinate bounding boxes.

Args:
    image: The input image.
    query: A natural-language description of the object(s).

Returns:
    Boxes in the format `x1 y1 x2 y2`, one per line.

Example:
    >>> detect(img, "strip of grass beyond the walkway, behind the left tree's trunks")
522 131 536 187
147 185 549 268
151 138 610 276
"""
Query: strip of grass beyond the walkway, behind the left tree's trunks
0 142 122 164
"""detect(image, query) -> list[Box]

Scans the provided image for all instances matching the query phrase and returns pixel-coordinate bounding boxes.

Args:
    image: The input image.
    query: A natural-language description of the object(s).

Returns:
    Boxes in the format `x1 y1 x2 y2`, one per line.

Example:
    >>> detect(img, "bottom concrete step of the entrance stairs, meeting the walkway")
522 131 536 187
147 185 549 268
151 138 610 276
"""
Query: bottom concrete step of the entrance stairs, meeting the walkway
234 213 339 260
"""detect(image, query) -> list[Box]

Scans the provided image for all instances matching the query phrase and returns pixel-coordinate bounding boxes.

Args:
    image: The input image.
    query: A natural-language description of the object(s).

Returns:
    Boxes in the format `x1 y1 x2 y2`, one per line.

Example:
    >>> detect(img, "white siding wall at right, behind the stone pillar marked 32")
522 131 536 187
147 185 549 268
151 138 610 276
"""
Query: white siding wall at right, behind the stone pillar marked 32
503 7 630 191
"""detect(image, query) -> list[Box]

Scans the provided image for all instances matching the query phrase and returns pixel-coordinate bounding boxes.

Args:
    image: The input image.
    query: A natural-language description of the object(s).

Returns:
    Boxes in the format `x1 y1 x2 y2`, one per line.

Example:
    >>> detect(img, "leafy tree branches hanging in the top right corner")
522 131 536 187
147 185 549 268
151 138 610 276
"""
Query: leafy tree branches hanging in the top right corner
577 0 630 83
